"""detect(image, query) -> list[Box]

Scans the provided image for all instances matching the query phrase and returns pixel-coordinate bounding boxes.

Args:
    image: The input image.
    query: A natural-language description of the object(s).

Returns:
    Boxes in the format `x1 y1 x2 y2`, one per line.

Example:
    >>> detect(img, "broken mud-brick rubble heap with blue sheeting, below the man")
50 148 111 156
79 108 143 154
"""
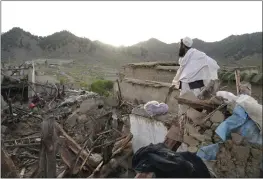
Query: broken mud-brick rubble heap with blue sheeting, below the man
177 88 263 178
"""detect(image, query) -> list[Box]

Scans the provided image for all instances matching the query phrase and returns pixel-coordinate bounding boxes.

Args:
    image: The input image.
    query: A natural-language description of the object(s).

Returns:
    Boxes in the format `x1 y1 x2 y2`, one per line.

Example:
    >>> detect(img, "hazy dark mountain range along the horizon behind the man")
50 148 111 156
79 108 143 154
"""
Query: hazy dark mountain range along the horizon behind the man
1 28 262 67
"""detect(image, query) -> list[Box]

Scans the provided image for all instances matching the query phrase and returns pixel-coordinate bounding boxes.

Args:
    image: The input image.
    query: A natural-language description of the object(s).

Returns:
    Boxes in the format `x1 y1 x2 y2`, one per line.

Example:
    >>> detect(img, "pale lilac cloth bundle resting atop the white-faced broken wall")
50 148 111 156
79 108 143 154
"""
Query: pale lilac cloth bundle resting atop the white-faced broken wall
144 101 169 116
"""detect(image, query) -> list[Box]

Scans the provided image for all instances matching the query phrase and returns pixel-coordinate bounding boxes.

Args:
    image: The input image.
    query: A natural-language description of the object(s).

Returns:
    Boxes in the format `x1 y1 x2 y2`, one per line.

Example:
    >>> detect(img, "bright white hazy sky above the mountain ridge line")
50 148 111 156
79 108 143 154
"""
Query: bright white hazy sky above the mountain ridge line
1 1 262 46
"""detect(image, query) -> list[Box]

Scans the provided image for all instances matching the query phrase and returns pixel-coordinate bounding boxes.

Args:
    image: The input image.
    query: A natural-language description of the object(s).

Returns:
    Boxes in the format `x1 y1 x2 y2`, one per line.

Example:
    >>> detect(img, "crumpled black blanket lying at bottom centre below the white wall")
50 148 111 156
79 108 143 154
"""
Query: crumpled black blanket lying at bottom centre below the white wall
132 143 210 178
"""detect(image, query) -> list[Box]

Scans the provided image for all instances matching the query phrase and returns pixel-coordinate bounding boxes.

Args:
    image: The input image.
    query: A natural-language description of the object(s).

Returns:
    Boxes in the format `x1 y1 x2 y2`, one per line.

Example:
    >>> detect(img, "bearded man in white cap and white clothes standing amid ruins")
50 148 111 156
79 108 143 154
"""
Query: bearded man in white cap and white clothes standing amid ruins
169 37 220 113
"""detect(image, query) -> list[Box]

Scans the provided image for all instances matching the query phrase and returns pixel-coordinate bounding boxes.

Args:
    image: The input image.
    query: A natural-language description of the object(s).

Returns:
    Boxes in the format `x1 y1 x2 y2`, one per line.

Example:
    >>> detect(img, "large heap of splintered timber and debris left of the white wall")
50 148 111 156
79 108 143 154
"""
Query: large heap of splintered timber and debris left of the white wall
1 82 135 178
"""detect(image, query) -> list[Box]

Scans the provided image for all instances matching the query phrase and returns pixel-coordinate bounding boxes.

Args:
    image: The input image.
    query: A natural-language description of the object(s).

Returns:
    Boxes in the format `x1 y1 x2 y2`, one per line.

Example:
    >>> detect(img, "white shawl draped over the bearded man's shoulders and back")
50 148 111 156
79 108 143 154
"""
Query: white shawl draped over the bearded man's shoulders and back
172 48 220 86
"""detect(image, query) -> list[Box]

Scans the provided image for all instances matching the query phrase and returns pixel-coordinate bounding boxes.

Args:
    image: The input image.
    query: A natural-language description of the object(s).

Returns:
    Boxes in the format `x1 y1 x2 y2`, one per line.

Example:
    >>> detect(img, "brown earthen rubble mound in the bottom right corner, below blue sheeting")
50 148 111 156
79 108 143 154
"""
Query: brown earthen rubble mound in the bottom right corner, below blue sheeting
213 133 262 178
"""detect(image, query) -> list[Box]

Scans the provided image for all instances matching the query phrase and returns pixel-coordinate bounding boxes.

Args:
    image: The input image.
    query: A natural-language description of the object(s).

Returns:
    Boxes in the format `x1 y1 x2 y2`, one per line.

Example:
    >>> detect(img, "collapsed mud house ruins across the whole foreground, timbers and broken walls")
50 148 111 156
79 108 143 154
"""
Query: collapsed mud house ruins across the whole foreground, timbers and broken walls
1 63 262 178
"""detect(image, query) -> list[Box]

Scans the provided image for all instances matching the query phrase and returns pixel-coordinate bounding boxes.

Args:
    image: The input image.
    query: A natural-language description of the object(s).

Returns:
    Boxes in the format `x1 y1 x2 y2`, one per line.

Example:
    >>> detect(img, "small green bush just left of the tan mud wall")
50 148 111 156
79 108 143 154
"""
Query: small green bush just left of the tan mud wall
90 80 113 96
